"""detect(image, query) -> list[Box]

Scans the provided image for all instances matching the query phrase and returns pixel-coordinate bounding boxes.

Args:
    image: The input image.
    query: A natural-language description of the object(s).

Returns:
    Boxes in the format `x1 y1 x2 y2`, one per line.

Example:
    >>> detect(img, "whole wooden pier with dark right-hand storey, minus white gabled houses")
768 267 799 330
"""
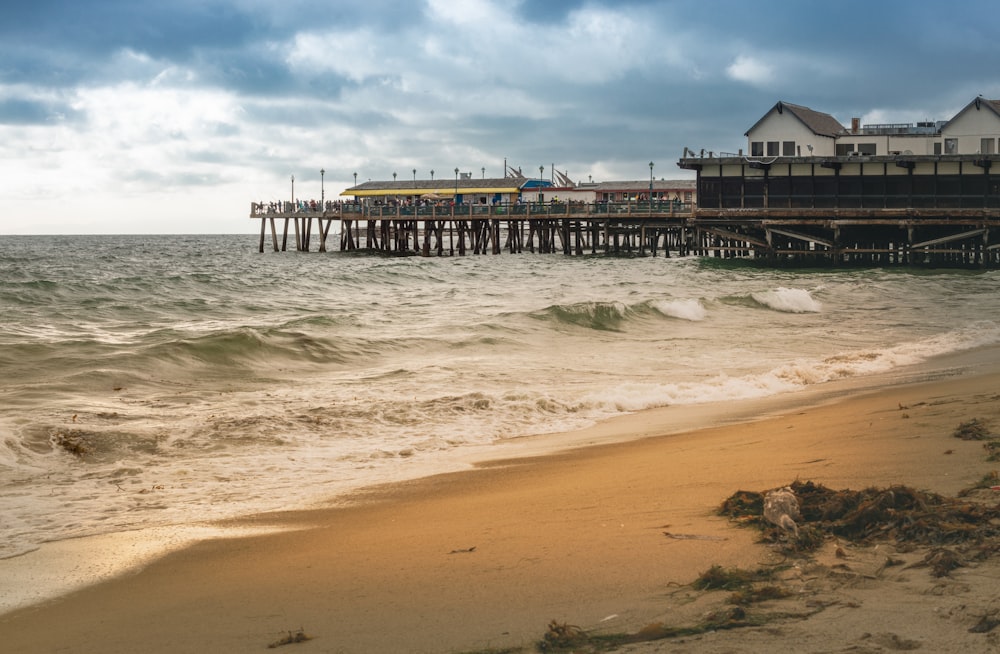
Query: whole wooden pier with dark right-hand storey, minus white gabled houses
250 155 1000 268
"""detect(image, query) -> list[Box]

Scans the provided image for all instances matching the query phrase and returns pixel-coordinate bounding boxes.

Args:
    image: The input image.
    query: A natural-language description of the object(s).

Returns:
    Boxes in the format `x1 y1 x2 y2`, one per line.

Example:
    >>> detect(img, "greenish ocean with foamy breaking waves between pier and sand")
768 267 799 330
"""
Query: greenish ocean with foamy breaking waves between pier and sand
0 235 1000 576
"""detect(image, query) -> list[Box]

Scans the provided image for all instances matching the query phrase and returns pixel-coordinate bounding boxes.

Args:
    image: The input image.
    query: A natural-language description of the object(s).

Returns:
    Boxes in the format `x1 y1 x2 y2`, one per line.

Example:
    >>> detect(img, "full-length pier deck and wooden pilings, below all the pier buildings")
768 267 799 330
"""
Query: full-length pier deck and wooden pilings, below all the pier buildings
251 202 1000 268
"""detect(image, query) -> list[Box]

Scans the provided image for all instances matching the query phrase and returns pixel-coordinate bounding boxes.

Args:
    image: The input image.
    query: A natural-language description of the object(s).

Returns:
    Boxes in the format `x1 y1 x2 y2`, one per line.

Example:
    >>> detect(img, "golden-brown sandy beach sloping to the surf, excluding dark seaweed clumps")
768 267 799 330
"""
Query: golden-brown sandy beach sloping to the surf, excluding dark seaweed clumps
0 372 1000 654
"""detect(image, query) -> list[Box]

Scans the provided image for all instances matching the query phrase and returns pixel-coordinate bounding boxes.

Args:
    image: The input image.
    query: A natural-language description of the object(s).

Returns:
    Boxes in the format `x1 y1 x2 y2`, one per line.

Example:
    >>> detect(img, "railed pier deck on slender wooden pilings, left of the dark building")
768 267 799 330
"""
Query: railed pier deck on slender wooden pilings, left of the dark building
251 201 693 256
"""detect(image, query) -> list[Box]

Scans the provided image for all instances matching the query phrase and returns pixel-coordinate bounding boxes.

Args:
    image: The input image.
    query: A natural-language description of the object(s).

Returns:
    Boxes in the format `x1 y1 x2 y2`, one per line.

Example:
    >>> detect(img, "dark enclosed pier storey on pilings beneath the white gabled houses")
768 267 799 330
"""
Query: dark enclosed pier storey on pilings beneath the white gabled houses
680 155 1000 266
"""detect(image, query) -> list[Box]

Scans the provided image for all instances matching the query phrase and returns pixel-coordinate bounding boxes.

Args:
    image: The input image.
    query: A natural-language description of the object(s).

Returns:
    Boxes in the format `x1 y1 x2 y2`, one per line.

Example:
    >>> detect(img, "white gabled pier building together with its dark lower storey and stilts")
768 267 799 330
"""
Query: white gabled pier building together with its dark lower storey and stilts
678 98 1000 267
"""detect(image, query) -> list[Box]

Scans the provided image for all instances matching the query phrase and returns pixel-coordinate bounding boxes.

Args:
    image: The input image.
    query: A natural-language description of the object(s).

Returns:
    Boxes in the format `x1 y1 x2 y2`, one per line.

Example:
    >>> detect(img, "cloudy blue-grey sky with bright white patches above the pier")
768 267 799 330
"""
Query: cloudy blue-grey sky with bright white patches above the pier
0 0 1000 234
